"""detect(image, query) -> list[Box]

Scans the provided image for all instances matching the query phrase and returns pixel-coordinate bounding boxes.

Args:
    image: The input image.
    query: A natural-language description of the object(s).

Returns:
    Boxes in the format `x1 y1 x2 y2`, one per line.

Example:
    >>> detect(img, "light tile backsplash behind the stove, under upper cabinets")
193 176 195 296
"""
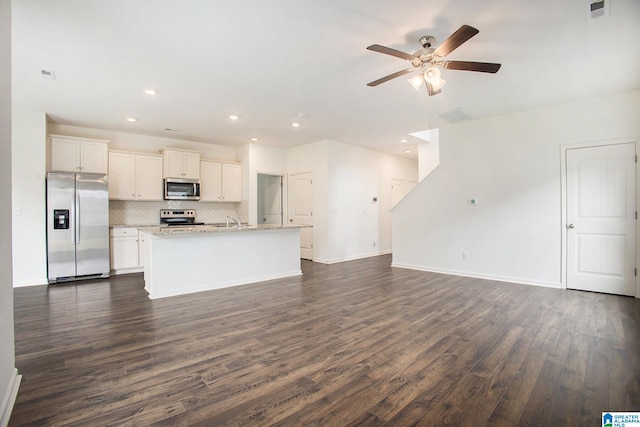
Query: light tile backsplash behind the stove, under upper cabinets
109 200 241 225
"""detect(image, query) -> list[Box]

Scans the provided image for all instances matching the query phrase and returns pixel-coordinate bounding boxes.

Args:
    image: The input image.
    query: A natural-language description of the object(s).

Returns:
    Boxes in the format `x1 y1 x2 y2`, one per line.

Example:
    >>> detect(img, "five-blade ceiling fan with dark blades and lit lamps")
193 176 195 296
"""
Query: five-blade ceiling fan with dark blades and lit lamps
367 25 501 96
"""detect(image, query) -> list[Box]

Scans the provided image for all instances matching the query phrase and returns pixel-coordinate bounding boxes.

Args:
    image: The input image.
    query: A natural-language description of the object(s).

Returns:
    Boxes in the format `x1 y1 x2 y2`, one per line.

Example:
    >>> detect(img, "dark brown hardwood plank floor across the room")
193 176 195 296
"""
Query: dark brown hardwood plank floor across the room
10 256 640 426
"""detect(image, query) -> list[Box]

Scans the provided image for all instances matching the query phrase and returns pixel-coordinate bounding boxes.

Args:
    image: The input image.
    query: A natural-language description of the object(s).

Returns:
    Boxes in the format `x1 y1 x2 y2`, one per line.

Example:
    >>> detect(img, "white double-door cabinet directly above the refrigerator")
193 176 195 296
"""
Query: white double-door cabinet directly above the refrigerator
51 135 109 174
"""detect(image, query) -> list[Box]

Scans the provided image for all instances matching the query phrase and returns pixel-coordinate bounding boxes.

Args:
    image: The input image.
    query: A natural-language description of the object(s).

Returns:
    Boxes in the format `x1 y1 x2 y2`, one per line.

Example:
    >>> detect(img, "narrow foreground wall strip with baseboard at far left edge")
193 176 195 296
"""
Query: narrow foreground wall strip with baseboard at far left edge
0 0 20 425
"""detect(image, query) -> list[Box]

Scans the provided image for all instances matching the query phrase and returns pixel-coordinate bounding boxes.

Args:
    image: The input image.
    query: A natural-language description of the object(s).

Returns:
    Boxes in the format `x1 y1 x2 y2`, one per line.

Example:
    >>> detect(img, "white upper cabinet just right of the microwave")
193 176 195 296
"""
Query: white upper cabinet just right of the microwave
200 160 242 202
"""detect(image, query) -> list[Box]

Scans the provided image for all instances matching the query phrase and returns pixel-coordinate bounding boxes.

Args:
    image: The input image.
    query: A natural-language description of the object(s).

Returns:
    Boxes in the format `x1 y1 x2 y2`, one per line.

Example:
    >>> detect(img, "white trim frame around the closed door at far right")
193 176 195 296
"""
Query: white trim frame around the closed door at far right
559 138 640 298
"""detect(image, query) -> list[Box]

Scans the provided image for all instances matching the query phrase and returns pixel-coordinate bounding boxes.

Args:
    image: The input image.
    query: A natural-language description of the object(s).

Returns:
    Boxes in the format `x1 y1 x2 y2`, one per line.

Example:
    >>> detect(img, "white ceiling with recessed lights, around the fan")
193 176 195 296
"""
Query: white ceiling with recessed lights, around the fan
12 0 640 155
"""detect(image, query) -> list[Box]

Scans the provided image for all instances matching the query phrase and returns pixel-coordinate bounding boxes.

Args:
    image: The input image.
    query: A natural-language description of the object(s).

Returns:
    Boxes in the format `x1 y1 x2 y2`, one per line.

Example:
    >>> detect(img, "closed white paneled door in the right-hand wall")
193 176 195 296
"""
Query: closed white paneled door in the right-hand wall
566 143 636 295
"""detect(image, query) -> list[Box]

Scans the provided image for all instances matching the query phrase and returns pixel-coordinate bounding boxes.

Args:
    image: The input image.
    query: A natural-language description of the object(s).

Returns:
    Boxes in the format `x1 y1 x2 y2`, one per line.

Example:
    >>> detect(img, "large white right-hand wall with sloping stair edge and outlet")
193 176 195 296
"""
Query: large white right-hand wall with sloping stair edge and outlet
392 91 640 287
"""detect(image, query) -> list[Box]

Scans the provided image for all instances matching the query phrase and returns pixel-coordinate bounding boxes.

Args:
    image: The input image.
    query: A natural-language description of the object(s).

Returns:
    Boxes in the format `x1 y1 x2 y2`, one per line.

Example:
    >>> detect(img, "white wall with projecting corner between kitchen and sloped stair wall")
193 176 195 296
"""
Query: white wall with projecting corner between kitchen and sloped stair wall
288 140 418 263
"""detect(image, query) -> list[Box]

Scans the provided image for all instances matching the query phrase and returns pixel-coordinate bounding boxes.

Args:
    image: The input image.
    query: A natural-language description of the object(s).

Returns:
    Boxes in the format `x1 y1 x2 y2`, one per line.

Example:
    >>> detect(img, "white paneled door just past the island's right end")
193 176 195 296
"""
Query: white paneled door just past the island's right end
289 172 313 259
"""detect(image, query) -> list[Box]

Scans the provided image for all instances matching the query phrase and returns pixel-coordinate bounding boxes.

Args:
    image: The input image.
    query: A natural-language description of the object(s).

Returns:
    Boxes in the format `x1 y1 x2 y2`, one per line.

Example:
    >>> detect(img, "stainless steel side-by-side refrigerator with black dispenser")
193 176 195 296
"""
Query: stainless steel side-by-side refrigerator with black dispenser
47 172 110 283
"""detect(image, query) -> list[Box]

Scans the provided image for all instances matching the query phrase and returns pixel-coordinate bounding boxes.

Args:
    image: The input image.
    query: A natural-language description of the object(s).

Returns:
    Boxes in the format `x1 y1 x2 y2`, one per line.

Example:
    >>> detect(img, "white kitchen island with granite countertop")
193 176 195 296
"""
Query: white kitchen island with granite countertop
138 225 305 299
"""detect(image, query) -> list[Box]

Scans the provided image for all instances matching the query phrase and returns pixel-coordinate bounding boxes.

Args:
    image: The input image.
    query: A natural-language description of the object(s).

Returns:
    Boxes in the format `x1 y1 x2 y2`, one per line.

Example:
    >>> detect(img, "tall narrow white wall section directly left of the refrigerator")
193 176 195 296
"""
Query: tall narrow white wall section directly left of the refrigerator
11 110 47 287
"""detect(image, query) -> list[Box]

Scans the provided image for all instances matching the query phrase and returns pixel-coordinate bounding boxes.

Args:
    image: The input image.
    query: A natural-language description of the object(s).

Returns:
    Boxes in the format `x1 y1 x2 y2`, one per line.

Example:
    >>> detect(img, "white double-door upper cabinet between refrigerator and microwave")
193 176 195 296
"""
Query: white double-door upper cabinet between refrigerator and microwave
109 151 163 201
